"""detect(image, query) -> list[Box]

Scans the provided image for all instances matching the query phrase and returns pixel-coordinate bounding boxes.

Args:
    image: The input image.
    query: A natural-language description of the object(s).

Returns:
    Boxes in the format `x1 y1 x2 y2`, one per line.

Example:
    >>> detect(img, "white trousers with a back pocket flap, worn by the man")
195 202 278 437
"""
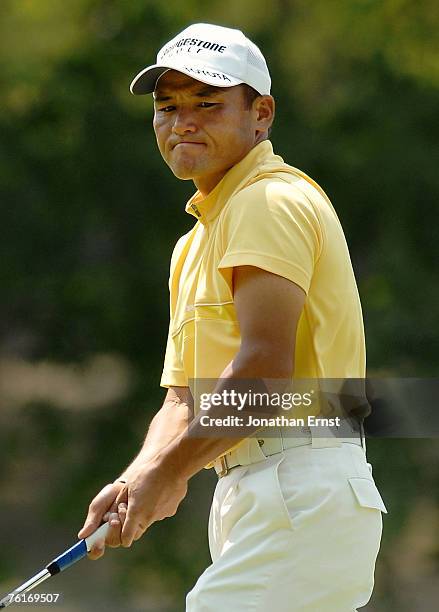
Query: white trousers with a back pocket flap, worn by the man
186 443 387 612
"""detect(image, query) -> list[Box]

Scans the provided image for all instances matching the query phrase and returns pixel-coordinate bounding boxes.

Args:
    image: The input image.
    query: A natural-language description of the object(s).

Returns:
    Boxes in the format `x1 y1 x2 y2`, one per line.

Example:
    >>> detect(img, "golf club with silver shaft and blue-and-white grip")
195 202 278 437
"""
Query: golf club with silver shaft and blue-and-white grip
0 523 109 608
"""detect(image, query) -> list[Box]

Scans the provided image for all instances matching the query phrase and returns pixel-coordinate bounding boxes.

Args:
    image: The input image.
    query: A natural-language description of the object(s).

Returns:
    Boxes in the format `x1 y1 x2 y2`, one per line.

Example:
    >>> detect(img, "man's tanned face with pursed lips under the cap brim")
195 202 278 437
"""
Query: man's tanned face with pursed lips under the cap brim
153 70 272 194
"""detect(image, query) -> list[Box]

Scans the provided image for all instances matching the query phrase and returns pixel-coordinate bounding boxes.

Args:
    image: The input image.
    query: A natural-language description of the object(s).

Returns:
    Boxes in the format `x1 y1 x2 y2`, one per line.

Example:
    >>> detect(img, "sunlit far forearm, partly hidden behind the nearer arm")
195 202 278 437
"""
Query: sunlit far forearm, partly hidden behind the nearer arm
118 387 192 481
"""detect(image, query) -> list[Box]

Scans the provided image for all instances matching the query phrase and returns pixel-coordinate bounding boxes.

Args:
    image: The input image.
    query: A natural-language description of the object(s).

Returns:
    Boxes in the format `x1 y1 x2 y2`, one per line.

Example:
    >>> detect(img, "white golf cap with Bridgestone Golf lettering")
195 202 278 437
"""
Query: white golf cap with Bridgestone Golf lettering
130 23 271 95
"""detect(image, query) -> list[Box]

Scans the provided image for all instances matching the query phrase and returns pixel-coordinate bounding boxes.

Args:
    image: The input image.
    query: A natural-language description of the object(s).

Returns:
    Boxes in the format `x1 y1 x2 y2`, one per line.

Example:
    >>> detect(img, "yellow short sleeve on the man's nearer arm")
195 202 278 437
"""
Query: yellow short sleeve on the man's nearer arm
218 179 322 293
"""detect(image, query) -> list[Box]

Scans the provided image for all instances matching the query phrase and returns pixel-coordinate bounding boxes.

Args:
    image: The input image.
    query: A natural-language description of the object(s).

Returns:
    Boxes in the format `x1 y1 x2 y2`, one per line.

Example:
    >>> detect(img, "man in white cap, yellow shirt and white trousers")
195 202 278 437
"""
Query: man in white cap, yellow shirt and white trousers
79 24 385 612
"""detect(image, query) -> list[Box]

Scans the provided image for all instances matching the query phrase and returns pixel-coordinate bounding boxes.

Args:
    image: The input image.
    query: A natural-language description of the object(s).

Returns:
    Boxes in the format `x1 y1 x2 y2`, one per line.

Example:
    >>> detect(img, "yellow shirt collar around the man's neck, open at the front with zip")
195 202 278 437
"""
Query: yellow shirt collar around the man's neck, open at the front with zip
185 140 283 224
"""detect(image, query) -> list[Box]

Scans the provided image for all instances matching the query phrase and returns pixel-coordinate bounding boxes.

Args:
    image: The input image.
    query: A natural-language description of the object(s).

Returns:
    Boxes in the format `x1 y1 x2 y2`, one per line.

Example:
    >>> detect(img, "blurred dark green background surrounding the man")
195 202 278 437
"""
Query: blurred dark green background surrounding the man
0 0 439 612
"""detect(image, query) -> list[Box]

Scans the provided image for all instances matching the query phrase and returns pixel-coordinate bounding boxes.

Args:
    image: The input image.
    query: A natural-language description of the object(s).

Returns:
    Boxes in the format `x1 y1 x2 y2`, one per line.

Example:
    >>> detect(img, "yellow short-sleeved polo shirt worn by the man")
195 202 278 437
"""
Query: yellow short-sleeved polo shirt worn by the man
160 140 365 387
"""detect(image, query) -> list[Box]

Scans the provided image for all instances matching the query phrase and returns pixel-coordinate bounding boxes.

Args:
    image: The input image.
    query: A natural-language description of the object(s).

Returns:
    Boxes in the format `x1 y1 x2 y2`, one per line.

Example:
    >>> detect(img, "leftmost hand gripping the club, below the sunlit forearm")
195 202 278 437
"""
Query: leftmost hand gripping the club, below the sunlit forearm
78 481 127 560
